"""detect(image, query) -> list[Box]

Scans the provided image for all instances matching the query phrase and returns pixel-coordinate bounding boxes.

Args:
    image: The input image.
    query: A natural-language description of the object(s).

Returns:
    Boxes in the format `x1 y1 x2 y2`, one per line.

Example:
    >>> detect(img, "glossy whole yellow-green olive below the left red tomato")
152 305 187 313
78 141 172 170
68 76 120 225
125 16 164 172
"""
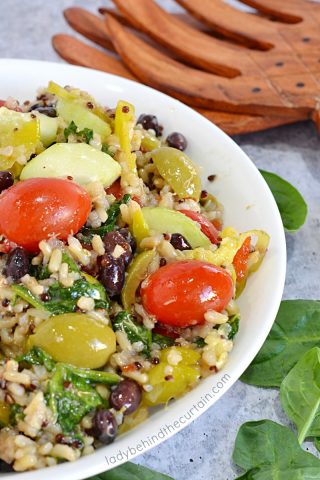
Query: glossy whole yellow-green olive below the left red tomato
27 313 116 368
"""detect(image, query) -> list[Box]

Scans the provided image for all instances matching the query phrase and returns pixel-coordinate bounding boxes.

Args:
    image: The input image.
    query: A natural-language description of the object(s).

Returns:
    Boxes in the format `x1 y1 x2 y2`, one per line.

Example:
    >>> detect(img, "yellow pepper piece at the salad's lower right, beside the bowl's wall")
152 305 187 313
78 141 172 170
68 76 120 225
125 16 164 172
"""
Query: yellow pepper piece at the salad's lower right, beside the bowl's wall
143 347 200 406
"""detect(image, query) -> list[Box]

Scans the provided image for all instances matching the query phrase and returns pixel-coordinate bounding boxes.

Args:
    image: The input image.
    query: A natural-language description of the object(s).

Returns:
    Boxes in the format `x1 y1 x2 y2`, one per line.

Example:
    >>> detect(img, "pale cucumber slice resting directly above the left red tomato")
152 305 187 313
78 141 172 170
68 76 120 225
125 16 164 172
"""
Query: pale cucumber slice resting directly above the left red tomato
20 143 121 187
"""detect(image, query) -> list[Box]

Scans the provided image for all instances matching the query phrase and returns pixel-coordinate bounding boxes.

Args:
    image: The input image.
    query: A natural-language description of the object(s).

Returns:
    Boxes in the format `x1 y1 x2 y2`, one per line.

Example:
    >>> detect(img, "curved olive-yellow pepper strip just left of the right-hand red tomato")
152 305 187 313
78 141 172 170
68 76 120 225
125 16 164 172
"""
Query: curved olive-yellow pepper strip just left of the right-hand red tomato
121 250 156 311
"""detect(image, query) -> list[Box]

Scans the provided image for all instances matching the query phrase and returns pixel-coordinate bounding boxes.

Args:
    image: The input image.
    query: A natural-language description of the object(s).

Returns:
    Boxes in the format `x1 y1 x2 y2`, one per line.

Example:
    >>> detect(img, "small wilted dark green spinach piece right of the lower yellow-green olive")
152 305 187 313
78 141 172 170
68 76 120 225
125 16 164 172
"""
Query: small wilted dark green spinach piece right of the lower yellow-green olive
113 311 152 357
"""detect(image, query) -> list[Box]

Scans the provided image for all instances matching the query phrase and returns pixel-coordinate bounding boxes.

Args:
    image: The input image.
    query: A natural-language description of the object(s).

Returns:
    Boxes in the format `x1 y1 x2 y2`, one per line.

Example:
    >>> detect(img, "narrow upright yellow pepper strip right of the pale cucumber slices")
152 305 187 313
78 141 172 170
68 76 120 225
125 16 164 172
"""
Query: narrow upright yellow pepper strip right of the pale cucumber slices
114 100 136 172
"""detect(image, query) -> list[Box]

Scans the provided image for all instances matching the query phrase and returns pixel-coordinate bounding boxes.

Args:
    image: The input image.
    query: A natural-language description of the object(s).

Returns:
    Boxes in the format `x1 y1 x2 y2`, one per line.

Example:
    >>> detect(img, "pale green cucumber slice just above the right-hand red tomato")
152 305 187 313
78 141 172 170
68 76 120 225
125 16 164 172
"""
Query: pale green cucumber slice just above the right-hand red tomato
142 207 211 248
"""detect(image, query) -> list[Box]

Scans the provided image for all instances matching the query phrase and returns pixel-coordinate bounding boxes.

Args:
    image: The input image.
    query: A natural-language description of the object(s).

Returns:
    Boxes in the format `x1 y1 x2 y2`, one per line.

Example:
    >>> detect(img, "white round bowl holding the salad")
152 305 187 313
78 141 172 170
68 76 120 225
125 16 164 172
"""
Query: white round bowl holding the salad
0 59 286 480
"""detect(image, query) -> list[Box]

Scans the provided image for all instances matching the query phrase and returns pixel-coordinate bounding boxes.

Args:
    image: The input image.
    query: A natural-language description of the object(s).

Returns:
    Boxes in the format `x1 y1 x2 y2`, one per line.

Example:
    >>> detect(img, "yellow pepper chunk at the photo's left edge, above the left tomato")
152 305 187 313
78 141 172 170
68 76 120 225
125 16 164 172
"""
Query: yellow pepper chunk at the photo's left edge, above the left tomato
0 107 40 170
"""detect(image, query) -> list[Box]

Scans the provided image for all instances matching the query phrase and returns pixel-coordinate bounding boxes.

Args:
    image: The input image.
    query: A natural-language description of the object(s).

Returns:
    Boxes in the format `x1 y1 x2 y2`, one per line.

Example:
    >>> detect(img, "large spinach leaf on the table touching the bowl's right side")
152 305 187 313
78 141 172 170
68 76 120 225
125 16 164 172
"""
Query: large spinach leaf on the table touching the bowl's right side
241 300 320 387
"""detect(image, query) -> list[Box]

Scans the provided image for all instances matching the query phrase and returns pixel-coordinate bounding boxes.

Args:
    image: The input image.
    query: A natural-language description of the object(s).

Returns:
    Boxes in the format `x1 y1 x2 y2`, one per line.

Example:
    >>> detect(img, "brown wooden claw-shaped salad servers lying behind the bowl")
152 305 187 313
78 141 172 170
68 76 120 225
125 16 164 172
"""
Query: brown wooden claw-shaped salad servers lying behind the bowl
53 0 320 134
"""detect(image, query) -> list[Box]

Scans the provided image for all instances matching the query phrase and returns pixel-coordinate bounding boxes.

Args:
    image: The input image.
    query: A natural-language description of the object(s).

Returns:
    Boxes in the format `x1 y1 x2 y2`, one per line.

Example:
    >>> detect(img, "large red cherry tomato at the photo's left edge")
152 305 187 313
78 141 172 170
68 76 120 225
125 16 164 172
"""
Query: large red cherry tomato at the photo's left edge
0 178 91 252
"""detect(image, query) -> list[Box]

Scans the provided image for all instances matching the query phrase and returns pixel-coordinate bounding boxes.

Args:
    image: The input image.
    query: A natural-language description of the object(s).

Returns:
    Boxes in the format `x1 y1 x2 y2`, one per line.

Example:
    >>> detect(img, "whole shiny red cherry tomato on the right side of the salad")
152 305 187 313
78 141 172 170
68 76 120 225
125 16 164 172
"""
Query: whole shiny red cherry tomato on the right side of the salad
141 260 233 327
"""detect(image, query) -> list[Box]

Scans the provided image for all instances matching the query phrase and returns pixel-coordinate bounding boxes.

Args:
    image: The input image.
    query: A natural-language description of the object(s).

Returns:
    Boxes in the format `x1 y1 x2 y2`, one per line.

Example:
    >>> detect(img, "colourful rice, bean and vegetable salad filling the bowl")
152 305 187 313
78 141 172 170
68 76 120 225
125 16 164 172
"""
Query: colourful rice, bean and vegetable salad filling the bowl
0 81 269 472
